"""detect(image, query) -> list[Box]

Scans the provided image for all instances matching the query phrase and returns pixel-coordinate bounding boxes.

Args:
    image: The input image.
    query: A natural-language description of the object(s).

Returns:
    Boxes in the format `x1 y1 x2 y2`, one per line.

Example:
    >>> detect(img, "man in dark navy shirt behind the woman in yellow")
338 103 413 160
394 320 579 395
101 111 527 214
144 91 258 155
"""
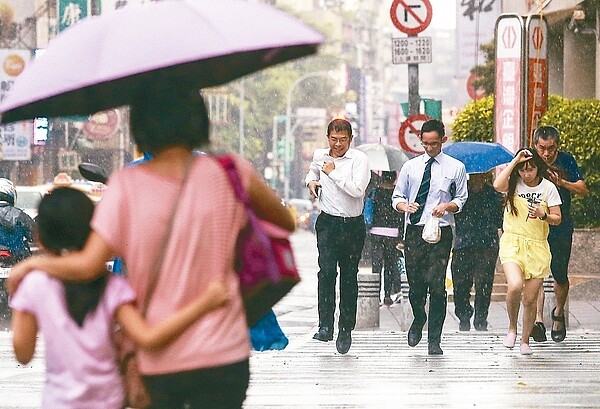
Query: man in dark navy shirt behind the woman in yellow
532 126 589 342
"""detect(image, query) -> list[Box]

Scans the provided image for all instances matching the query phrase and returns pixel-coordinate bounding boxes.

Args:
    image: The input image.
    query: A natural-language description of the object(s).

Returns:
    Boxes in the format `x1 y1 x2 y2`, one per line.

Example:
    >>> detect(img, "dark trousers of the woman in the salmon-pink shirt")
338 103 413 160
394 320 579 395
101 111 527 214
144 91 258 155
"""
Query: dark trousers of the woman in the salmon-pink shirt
144 358 250 409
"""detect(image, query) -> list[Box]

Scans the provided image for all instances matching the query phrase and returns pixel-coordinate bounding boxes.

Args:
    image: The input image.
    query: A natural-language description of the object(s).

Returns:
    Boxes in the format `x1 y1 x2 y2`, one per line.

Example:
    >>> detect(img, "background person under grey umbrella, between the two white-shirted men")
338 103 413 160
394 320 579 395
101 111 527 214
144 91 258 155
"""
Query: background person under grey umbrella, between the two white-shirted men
369 171 404 306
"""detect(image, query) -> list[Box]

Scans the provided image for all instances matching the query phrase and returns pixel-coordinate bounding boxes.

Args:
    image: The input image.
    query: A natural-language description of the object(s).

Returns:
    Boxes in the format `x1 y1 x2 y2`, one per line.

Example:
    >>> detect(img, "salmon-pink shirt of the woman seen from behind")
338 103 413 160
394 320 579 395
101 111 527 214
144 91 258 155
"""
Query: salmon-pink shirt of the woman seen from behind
92 156 254 374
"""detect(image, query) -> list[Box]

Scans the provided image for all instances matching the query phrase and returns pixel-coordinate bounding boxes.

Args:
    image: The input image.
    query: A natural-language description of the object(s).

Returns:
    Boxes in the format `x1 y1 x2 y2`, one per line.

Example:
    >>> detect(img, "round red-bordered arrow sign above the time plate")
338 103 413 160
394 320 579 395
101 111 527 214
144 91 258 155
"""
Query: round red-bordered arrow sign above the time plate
390 0 433 35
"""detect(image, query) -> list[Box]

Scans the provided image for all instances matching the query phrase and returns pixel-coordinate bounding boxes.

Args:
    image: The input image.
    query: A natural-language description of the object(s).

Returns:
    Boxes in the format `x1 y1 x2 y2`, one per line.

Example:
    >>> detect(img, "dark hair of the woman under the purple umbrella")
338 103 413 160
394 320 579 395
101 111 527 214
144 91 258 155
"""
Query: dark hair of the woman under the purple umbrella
129 78 210 154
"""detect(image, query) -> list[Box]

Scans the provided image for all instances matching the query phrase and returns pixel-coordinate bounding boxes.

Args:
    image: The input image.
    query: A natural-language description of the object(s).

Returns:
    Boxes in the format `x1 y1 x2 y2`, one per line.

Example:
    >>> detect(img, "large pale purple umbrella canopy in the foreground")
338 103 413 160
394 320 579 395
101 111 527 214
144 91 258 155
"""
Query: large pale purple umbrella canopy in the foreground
0 0 323 123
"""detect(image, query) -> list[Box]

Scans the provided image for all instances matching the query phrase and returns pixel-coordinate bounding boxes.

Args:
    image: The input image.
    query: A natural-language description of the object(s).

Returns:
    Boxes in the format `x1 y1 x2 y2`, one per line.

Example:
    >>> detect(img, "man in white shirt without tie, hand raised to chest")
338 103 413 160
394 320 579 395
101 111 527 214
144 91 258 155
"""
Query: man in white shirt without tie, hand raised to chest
305 119 371 354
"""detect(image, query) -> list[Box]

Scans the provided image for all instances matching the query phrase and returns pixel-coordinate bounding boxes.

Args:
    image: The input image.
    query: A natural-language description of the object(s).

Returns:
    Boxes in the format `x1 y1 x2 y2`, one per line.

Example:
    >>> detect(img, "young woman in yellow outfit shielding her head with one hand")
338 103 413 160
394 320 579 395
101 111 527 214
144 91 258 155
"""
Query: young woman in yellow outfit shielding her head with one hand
494 148 561 355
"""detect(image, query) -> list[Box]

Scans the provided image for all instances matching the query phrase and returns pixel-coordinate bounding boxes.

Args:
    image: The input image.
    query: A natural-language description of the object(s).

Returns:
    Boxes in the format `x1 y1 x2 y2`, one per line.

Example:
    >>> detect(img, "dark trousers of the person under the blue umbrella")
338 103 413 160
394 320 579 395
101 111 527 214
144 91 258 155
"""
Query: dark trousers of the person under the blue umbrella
451 245 498 324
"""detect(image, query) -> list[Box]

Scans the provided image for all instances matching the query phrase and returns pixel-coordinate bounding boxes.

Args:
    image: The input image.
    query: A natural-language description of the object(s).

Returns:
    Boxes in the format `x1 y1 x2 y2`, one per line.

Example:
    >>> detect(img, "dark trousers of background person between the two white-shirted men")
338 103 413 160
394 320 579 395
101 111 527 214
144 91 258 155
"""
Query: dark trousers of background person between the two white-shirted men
371 234 401 297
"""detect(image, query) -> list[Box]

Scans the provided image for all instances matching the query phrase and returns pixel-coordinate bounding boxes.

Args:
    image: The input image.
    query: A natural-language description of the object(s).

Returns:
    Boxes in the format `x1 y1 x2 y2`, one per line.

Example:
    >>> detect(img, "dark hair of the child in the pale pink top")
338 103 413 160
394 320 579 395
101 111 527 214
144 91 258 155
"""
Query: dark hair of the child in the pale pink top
37 187 108 327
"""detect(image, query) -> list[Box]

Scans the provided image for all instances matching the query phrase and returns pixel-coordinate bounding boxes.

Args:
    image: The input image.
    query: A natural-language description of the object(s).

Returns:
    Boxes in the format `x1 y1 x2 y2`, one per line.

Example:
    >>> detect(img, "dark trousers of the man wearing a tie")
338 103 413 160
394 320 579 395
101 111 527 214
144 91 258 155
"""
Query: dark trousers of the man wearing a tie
404 224 452 343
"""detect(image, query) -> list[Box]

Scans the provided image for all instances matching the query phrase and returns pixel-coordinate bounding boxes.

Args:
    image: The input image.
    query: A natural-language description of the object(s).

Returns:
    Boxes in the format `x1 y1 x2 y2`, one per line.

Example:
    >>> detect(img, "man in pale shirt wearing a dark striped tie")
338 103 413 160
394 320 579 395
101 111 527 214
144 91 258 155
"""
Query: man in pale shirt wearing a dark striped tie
392 119 468 355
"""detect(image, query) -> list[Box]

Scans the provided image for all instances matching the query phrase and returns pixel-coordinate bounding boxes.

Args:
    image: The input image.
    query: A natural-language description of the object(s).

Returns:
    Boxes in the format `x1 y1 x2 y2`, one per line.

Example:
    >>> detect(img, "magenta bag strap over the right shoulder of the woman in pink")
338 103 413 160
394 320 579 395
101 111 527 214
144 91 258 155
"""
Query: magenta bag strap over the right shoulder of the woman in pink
215 155 280 282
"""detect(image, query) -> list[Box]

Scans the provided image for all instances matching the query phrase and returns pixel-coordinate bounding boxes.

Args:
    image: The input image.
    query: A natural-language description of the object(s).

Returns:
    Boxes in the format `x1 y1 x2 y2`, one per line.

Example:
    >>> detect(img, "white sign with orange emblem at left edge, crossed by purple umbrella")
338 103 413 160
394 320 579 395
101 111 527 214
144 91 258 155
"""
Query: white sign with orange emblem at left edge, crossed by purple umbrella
0 49 33 160
